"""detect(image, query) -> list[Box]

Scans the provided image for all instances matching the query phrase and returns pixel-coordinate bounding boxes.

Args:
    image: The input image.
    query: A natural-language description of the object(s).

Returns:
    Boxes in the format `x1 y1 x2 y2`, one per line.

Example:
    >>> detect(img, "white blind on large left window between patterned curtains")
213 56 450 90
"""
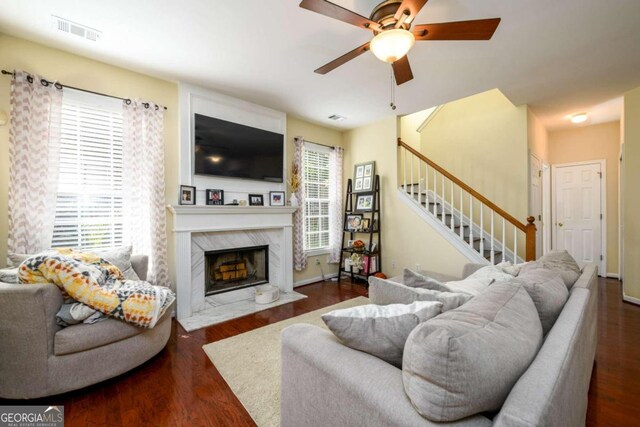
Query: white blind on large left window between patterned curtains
51 89 127 249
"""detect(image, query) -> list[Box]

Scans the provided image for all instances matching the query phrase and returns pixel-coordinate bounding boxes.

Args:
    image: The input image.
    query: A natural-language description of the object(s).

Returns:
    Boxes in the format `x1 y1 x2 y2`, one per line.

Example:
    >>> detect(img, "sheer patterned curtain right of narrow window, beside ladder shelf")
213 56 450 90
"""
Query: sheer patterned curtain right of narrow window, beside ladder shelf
329 147 344 263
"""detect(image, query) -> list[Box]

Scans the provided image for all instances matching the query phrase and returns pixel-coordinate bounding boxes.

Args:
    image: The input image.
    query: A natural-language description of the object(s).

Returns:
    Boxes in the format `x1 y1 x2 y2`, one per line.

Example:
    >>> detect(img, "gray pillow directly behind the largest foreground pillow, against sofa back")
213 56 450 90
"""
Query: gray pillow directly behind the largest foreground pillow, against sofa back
514 268 569 335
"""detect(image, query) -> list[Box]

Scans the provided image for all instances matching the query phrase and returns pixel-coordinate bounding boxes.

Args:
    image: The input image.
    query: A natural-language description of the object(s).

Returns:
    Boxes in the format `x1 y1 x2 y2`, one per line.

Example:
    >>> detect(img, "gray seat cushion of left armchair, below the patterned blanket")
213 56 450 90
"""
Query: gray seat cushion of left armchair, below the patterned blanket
53 309 171 356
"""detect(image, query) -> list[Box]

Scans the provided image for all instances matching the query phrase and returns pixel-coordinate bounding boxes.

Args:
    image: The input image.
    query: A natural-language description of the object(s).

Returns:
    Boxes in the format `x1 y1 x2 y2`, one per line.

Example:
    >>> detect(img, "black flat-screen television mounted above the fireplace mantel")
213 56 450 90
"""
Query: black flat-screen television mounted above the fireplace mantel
194 114 284 182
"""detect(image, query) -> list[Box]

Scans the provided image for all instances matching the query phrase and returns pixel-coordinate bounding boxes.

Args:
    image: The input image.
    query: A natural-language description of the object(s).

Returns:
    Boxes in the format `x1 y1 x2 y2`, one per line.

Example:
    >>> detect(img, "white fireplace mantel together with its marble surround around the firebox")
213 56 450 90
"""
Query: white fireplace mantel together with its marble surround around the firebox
169 205 295 320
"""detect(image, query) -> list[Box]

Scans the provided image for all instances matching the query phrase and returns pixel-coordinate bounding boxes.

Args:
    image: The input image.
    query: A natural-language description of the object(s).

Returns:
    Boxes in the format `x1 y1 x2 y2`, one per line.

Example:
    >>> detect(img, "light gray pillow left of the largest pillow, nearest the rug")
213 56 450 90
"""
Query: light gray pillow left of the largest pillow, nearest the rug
322 301 442 367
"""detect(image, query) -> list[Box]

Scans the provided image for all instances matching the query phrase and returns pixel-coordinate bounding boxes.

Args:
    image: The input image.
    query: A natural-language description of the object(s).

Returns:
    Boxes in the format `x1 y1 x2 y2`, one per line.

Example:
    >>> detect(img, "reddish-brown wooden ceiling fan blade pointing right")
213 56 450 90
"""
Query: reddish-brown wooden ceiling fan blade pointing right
411 18 500 40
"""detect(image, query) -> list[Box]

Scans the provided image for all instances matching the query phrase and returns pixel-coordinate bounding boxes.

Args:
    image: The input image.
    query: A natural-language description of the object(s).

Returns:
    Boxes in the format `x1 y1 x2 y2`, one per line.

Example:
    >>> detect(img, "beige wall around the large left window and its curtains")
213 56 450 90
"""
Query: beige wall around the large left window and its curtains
0 34 179 277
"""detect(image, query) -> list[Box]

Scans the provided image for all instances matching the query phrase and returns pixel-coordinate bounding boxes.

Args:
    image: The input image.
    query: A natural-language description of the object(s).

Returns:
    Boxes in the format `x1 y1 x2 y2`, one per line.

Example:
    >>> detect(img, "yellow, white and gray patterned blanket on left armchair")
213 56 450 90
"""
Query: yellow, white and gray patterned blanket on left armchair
18 249 176 328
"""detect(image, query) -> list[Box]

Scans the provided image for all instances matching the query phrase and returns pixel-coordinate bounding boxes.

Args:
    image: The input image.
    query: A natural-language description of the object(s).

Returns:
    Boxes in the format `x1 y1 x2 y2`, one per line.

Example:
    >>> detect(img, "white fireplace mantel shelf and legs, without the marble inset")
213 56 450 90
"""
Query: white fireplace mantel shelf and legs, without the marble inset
167 205 297 319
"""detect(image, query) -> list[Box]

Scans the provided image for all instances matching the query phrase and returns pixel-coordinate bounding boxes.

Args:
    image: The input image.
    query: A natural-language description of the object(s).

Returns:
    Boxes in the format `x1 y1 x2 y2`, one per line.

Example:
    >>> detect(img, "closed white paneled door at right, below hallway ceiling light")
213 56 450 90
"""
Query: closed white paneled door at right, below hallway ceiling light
553 162 605 275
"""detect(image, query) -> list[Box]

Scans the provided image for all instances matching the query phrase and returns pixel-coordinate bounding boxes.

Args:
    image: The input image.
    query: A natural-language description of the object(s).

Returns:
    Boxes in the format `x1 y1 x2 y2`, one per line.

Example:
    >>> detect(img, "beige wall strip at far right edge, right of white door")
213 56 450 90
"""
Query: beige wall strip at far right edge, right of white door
622 87 640 303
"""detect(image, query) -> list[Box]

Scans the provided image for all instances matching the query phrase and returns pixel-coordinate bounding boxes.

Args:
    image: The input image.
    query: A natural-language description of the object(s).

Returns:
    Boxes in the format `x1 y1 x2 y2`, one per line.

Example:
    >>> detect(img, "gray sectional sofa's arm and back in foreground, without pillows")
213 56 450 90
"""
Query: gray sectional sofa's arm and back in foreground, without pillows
281 265 598 427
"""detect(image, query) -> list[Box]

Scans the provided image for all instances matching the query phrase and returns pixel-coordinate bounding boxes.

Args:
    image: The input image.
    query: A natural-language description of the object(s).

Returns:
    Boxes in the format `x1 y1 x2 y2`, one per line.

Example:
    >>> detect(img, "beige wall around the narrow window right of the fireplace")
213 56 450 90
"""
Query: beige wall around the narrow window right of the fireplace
286 116 349 283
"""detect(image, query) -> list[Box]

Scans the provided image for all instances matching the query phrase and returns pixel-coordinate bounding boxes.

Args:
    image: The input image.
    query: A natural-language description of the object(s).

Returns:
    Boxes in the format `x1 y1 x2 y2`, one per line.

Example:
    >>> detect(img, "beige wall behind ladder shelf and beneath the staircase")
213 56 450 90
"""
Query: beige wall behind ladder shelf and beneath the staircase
344 116 467 276
